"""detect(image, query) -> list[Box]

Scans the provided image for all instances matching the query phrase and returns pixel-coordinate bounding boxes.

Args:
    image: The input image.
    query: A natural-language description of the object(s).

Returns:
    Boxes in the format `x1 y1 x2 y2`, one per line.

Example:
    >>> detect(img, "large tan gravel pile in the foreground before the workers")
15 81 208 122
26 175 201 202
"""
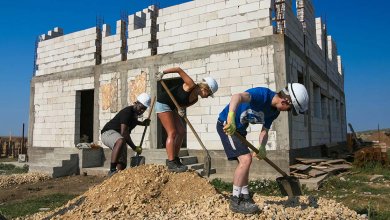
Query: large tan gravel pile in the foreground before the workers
24 165 361 219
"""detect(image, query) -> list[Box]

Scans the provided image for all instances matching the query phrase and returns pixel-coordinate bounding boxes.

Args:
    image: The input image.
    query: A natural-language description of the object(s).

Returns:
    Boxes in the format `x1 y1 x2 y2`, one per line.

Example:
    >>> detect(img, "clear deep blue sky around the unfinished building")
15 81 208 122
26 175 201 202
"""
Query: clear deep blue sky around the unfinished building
0 0 390 136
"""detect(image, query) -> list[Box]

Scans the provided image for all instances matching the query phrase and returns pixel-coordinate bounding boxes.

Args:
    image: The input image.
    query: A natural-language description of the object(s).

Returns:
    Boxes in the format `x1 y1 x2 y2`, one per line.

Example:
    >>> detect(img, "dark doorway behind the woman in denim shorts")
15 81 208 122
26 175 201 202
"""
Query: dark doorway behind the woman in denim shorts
157 77 187 149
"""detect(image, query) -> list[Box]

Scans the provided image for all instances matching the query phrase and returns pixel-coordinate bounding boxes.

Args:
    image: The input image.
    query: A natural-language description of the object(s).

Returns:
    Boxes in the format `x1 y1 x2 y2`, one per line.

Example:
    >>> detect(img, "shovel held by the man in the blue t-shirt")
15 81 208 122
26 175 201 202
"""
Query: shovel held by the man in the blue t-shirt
234 131 302 197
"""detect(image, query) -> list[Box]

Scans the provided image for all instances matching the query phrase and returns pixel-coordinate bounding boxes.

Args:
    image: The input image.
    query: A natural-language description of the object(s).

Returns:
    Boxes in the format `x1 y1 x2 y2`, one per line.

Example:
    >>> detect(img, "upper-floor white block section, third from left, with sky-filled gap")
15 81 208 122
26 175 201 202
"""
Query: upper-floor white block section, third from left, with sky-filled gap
127 5 158 60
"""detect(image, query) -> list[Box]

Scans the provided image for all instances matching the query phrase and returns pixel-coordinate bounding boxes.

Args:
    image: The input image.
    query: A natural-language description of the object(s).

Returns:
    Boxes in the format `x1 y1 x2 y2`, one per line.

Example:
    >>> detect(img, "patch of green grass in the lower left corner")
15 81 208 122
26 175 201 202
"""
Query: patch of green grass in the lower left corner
0 194 76 219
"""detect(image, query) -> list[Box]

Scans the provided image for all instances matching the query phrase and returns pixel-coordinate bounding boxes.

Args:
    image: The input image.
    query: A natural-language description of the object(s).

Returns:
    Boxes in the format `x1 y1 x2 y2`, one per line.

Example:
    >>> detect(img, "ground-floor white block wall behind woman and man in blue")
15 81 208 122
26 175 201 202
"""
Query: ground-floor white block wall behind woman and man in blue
159 45 281 150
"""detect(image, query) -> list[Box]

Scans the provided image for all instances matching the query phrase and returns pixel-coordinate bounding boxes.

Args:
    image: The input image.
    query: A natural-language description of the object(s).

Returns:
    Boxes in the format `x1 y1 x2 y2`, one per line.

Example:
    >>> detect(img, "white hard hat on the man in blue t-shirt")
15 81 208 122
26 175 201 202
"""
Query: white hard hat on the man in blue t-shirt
287 83 309 115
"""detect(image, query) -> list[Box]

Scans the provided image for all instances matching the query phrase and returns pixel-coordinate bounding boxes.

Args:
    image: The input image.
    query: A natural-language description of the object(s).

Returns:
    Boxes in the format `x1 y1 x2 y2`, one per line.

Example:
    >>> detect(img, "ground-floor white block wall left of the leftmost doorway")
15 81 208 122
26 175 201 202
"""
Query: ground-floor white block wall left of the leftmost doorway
32 77 94 147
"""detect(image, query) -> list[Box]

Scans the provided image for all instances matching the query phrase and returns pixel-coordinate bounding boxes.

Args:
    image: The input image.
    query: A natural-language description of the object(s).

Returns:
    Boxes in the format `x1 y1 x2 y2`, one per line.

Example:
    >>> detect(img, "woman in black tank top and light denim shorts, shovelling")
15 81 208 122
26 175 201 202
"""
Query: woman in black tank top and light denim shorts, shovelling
156 67 218 172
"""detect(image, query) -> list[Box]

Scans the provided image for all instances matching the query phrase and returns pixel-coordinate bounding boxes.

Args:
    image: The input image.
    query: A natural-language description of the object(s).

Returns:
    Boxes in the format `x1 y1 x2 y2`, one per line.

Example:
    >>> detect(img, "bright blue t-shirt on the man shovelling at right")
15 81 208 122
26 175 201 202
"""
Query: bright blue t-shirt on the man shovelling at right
218 87 280 135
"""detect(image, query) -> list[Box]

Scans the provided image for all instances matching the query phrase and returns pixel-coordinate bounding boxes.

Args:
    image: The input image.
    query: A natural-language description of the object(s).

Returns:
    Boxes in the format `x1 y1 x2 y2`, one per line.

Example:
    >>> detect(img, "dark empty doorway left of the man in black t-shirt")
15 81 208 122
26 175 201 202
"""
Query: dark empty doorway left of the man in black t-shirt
76 89 94 143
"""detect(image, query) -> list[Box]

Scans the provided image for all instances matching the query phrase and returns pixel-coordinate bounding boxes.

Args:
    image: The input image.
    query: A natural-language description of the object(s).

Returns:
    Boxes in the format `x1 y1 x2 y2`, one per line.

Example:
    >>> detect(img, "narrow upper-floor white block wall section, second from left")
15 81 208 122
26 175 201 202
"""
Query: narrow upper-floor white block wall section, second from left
102 20 127 64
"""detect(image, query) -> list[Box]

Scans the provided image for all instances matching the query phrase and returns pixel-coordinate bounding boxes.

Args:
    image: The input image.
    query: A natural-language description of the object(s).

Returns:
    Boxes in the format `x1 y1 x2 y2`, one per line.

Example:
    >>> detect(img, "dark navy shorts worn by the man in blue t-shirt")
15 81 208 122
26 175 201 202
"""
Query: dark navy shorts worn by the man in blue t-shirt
217 121 250 160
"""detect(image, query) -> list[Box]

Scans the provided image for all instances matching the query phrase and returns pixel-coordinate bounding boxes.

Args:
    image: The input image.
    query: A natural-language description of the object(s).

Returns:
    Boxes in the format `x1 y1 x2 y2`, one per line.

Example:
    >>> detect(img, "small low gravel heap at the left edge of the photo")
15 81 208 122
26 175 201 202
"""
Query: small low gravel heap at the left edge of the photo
0 173 50 188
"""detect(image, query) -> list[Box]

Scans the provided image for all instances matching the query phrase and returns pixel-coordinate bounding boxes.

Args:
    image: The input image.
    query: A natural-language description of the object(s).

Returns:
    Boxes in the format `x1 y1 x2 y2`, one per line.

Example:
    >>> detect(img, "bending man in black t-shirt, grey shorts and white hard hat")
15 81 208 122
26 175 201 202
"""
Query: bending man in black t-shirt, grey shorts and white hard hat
101 93 150 176
